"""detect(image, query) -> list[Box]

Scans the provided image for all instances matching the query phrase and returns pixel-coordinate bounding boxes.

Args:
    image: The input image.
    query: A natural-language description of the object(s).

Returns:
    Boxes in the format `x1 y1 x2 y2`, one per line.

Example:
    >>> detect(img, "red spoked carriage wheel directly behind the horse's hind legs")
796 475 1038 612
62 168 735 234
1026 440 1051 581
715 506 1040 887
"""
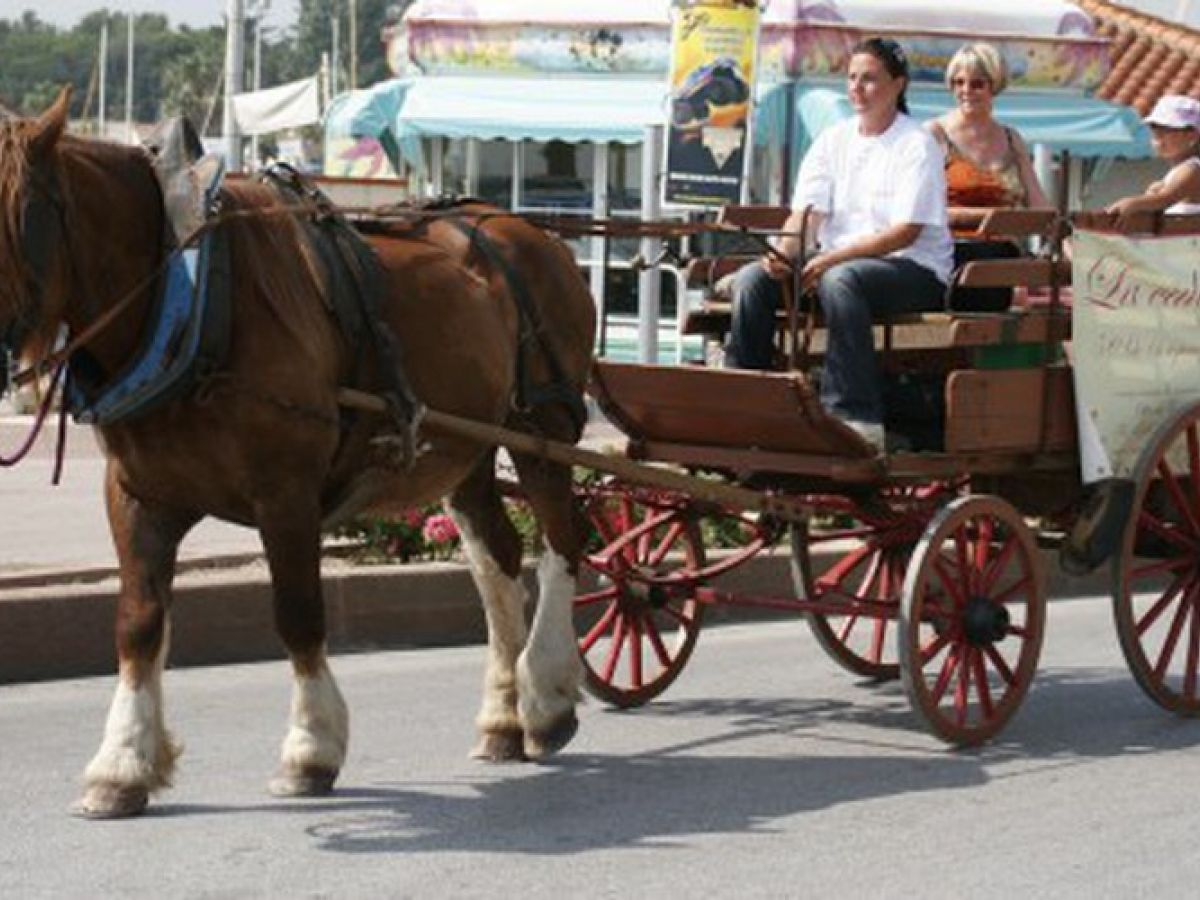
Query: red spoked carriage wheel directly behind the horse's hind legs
575 491 704 707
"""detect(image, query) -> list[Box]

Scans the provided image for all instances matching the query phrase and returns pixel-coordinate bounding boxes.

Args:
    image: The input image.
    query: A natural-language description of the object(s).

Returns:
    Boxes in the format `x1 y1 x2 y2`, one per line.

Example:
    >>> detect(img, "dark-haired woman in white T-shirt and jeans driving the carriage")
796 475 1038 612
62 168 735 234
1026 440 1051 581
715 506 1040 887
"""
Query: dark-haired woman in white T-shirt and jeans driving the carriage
726 37 953 450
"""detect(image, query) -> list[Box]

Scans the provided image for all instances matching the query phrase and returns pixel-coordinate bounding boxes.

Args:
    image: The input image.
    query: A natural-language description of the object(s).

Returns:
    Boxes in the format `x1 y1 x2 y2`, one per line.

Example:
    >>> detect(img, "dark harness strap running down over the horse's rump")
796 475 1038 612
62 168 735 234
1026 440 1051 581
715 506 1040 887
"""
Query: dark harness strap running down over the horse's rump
448 217 588 433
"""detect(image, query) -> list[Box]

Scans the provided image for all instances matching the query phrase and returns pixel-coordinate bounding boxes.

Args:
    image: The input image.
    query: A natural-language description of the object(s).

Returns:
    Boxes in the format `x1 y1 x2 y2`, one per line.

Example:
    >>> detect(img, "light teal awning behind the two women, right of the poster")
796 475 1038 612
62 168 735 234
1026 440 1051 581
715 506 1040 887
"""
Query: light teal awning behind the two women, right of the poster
796 84 1153 160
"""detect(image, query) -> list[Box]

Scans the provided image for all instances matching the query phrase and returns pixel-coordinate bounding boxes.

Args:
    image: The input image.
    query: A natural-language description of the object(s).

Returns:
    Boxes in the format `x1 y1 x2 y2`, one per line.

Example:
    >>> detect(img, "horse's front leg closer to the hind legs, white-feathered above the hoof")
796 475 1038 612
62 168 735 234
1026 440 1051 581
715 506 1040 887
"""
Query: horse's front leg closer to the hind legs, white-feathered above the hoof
259 499 349 797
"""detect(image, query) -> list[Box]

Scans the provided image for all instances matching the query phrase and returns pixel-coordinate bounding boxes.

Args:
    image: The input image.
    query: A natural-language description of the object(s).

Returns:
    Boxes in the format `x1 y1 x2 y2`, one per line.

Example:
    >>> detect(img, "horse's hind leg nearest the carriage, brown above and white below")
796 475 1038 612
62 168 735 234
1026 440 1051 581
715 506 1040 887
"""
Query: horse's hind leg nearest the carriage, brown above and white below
514 454 583 760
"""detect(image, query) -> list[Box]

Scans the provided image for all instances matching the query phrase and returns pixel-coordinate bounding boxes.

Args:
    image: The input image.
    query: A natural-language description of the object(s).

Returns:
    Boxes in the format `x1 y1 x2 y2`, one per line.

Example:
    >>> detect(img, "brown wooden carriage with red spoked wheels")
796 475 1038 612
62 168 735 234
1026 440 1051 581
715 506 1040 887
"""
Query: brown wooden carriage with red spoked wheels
564 210 1200 745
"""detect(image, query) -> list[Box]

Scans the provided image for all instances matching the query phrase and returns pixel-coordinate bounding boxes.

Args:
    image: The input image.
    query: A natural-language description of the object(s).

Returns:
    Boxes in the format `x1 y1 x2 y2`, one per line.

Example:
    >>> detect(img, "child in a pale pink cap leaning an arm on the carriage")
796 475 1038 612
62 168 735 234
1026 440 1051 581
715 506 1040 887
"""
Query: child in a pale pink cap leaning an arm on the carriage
1108 94 1200 218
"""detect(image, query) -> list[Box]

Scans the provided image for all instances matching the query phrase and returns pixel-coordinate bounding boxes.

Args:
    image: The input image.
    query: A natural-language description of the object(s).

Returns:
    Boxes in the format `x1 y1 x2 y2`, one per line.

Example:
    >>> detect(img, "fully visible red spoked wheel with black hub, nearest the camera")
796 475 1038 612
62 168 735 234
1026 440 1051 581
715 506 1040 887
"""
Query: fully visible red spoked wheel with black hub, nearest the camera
899 496 1045 746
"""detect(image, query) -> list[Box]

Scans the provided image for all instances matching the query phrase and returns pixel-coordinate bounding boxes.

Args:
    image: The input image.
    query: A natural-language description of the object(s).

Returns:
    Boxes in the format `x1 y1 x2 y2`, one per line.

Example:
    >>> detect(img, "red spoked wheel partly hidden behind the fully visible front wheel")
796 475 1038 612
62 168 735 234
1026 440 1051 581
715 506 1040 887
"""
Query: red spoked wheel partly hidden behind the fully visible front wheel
792 485 950 680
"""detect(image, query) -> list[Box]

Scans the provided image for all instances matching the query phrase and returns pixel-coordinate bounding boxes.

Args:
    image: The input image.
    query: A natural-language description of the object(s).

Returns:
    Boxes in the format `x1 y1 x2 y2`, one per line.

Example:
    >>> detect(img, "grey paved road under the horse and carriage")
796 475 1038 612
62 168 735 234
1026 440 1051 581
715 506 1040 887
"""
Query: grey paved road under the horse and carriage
0 599 1200 900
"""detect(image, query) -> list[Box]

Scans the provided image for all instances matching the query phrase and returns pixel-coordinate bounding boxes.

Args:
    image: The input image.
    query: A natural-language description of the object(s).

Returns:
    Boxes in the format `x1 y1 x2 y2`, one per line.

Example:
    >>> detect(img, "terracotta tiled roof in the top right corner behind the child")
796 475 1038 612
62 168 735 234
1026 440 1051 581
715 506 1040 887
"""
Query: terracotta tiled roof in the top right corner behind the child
1075 0 1200 115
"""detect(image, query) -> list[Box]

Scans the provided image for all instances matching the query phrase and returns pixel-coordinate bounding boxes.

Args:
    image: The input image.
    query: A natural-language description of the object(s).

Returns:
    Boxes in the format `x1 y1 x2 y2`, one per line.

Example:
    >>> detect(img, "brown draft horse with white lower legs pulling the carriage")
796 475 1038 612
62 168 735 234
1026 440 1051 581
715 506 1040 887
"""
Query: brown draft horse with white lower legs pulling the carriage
0 94 595 816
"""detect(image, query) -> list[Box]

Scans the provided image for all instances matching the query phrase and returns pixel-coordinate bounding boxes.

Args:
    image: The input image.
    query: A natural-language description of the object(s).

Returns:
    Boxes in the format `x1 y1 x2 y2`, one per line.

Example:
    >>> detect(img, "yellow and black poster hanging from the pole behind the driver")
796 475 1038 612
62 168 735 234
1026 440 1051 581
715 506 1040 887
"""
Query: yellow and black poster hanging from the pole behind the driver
662 0 760 206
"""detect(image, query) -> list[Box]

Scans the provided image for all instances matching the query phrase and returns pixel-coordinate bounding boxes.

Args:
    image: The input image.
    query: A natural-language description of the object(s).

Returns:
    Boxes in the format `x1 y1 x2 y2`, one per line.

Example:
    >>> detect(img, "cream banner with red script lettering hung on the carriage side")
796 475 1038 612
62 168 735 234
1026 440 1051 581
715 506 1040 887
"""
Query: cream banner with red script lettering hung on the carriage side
1072 228 1200 484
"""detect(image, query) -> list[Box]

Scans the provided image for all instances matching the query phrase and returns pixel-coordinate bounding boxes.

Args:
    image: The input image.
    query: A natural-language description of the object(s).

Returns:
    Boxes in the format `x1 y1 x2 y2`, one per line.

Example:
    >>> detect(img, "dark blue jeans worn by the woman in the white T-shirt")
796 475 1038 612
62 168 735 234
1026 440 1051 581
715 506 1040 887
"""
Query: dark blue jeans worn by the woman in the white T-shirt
725 257 946 422
